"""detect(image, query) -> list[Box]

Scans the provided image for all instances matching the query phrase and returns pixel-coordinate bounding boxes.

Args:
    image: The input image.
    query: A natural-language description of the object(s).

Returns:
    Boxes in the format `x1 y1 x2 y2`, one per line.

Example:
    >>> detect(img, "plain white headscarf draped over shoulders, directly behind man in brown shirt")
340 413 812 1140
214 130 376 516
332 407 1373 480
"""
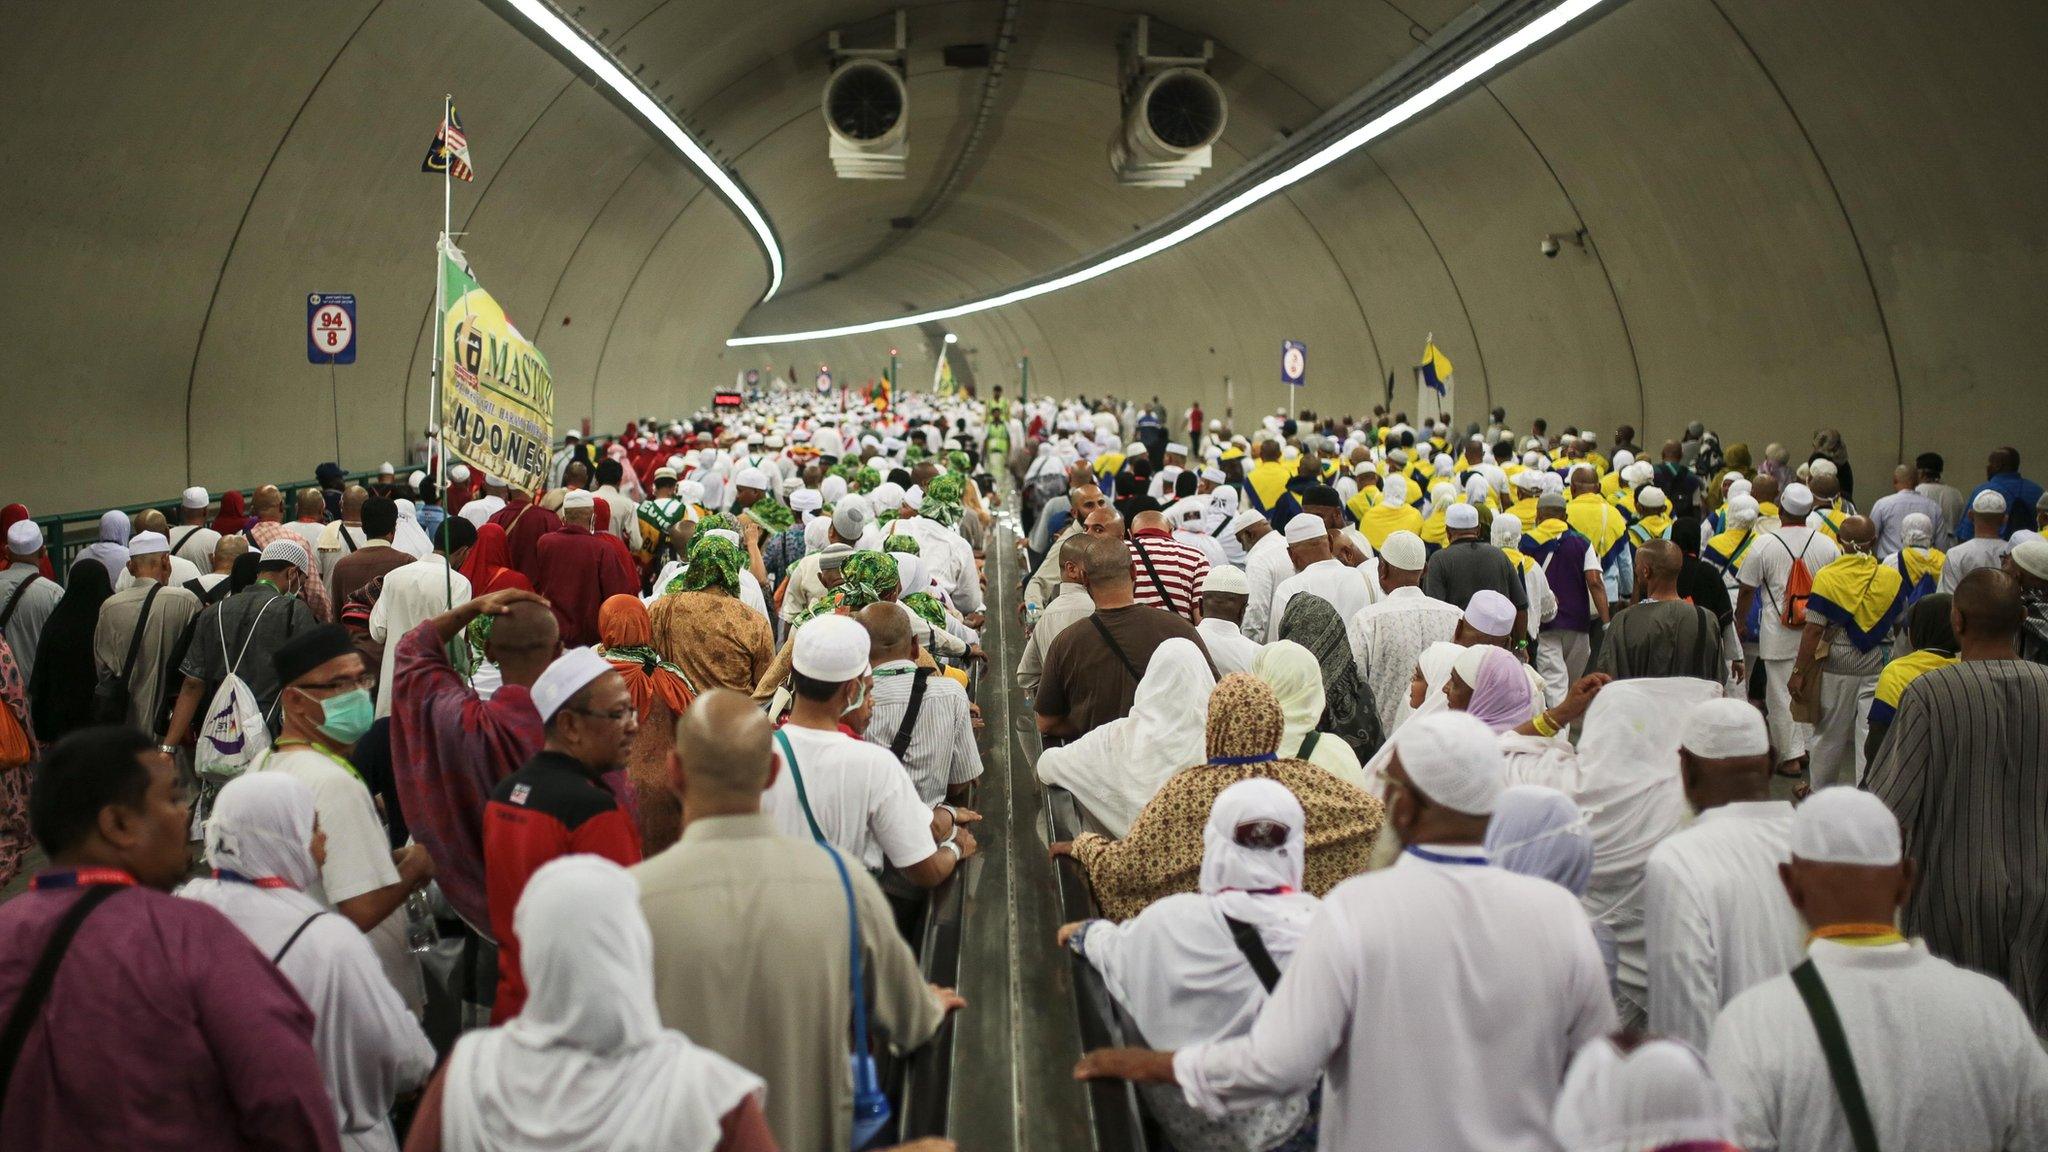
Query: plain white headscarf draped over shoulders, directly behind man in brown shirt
1038 637 1217 836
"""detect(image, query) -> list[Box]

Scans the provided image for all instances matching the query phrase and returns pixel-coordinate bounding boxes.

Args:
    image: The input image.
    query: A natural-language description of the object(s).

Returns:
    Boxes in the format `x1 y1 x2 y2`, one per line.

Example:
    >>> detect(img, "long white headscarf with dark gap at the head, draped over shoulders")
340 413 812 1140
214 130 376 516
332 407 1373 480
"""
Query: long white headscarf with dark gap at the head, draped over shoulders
1083 779 1317 1047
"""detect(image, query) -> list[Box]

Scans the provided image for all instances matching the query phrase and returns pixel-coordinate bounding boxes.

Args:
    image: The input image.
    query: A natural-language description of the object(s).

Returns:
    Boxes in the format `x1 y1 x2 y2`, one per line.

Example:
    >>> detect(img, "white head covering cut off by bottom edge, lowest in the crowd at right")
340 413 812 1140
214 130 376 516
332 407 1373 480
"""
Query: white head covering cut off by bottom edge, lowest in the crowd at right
1550 1037 1735 1152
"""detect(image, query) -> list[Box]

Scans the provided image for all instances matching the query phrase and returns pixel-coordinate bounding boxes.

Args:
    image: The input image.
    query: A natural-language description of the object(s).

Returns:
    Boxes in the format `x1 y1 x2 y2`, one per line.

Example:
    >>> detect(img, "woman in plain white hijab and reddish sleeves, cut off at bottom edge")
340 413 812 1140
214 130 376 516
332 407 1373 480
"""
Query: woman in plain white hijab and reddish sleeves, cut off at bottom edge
406 855 774 1152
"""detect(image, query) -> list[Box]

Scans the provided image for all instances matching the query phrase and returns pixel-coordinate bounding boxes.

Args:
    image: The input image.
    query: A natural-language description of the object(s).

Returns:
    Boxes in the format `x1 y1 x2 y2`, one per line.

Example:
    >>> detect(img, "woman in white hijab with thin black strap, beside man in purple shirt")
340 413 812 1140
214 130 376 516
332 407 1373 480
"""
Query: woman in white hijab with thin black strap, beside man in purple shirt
178 773 434 1152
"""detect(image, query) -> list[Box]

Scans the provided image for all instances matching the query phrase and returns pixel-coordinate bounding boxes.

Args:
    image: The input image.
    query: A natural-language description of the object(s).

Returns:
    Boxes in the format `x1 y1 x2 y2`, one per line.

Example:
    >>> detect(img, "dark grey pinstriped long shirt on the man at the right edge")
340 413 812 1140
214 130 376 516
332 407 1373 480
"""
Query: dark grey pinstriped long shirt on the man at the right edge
1864 660 2048 1035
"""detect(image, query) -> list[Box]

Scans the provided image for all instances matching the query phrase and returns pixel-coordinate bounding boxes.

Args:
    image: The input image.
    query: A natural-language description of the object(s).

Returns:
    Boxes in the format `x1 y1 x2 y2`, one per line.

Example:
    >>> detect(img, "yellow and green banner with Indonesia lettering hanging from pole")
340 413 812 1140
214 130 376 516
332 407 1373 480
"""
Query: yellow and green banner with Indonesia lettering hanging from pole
440 238 555 492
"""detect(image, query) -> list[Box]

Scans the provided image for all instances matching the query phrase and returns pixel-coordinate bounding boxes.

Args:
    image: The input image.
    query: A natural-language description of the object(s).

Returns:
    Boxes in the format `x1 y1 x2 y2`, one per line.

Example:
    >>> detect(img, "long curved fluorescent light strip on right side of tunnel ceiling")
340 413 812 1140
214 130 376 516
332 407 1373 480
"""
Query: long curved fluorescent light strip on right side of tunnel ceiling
725 0 1606 348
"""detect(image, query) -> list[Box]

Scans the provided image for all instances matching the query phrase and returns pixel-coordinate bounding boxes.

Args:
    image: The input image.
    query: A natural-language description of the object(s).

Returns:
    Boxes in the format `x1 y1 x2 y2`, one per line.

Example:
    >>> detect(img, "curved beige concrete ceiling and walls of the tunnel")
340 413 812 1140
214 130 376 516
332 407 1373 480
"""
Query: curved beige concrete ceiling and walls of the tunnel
0 0 2048 512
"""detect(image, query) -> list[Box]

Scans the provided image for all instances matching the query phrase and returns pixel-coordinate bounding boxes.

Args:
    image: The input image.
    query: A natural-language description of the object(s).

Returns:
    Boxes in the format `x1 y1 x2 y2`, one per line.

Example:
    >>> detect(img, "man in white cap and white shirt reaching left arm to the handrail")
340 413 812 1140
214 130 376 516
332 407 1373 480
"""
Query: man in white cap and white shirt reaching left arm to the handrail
1075 711 1616 1152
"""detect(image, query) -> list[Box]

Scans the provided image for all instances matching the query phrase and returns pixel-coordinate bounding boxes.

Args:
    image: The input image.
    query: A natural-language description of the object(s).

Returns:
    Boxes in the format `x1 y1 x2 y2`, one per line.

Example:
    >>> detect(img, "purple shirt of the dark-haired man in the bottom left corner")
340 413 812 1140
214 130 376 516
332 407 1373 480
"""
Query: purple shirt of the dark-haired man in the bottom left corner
0 873 340 1152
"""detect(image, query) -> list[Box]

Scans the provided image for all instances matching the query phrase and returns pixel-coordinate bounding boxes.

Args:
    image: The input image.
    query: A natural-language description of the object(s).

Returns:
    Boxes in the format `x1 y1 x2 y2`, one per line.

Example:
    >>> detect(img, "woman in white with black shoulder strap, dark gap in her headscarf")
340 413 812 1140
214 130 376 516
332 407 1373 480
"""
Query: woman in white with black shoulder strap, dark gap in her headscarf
1059 774 1317 1152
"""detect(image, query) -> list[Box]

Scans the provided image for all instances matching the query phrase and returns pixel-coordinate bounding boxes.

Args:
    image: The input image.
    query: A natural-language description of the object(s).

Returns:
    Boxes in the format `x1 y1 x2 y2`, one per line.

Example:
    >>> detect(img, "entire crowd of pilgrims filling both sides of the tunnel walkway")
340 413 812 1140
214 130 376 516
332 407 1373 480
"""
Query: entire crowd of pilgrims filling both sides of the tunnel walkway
0 387 2048 1152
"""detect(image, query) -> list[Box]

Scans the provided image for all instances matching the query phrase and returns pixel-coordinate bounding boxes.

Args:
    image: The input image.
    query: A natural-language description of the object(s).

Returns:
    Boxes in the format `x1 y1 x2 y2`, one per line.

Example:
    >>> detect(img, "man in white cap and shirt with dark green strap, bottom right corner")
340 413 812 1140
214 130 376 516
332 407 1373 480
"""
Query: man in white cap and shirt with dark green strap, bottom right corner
1703 787 2048 1152
